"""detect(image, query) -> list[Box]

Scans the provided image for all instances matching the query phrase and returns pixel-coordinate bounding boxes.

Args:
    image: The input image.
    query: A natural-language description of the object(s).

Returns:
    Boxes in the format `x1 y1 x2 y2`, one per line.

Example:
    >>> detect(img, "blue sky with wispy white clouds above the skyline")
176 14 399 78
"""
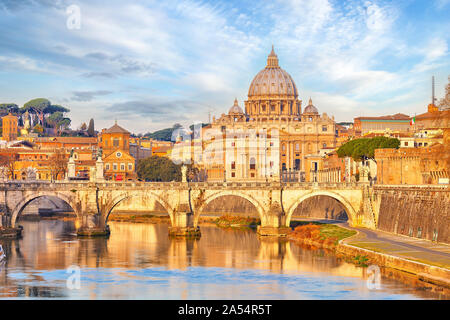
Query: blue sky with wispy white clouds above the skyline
0 0 450 133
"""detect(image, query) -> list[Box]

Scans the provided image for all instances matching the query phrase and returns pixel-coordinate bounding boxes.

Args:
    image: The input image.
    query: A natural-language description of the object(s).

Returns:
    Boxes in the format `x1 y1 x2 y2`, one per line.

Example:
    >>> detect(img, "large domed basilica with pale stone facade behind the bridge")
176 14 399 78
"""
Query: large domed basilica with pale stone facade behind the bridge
202 47 336 181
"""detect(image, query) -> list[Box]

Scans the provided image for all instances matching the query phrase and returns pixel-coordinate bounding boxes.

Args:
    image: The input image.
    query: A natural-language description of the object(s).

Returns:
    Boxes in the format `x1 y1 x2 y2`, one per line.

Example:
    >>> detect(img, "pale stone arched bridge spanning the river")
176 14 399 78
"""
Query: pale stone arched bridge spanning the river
0 181 378 236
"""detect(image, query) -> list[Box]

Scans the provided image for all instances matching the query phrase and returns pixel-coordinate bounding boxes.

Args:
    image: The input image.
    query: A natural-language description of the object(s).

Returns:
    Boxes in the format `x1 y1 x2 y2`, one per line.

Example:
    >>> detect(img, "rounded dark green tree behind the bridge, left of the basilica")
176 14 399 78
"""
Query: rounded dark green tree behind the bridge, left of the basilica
136 156 181 181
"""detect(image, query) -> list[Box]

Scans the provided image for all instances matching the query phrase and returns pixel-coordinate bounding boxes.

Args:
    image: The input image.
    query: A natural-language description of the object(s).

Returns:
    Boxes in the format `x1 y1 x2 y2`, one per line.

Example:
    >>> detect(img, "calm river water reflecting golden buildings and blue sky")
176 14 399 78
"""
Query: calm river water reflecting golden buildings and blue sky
0 220 440 299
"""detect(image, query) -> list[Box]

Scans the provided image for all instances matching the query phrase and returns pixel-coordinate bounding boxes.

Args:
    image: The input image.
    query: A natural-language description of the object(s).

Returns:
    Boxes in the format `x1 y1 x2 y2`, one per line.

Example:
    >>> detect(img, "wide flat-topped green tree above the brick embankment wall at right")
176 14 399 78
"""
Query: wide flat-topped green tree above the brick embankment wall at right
337 137 400 161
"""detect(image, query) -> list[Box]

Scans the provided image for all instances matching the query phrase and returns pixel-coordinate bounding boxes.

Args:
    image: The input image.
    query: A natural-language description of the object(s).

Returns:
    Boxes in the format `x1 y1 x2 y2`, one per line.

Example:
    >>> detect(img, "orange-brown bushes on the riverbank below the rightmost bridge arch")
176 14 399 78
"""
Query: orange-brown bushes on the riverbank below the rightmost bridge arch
290 222 356 248
